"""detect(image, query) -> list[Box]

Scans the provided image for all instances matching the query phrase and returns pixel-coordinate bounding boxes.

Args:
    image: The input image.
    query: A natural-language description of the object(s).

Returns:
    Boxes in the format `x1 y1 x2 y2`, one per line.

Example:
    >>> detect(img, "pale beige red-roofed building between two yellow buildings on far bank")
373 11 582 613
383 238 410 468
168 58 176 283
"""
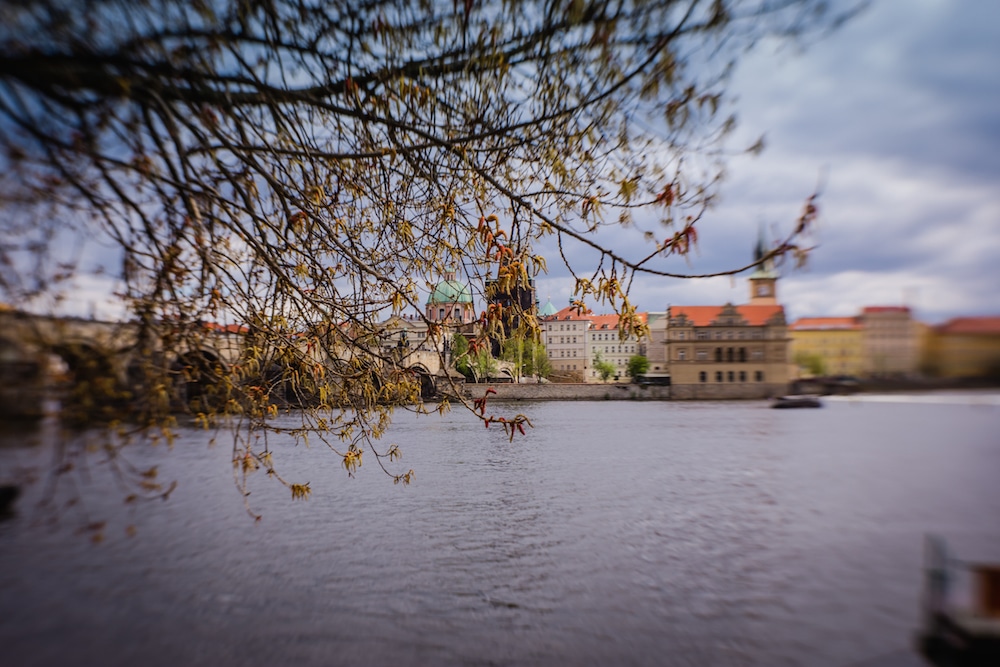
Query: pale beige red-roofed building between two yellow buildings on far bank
858 306 920 377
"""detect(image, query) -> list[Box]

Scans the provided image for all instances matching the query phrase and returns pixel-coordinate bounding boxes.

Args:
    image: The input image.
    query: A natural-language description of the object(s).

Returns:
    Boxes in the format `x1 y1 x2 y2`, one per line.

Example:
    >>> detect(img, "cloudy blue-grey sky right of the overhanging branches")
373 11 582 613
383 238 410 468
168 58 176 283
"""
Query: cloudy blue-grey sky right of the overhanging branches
539 0 1000 323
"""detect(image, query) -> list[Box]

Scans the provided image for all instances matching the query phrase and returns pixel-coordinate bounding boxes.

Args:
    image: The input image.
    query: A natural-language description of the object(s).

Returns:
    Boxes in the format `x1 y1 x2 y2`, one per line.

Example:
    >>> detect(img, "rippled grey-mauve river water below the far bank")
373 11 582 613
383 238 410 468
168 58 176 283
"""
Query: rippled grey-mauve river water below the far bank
0 394 1000 667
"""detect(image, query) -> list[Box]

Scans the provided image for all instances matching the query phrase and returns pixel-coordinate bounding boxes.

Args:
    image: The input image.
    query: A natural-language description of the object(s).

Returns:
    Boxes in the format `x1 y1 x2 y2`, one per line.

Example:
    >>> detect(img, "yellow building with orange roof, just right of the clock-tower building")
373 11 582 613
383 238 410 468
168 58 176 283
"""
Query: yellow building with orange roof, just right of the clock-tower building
788 317 865 377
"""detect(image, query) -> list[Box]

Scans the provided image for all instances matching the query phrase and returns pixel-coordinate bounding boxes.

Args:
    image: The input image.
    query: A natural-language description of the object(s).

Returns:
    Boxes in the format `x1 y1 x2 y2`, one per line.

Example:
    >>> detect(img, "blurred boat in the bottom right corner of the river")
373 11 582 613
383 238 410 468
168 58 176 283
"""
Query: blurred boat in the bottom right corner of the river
917 535 1000 667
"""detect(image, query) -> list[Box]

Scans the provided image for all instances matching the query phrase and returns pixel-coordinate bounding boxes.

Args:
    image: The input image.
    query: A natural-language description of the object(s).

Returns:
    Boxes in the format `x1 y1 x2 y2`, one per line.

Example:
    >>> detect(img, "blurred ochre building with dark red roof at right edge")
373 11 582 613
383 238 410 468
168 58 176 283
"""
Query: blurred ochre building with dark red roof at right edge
921 317 1000 379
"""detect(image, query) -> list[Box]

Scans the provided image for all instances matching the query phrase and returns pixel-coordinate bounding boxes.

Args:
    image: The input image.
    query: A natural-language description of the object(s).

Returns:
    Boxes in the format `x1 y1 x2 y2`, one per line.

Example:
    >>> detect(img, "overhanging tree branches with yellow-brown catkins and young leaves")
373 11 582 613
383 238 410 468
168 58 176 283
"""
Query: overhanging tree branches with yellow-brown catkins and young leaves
0 0 852 516
